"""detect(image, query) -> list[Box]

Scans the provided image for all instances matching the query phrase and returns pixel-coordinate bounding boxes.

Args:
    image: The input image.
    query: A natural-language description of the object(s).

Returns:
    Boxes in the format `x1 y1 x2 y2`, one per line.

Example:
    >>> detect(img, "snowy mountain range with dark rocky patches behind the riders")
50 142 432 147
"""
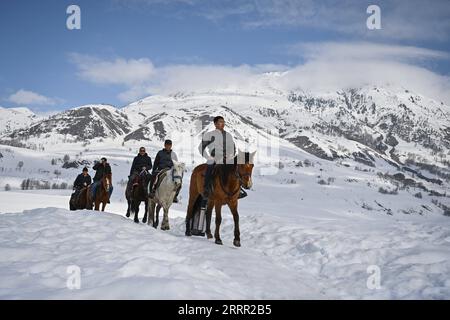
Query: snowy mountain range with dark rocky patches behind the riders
0 85 450 208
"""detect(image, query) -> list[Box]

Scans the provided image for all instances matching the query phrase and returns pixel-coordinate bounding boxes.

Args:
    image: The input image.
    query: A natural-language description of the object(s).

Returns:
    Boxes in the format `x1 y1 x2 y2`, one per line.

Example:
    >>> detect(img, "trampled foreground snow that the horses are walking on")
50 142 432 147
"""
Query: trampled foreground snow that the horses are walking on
0 175 450 299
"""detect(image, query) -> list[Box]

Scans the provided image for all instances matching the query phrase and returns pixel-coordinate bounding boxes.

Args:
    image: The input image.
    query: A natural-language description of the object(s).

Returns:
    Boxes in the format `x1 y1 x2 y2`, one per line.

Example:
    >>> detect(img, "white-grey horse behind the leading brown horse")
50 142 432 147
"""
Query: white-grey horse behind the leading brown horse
142 161 186 230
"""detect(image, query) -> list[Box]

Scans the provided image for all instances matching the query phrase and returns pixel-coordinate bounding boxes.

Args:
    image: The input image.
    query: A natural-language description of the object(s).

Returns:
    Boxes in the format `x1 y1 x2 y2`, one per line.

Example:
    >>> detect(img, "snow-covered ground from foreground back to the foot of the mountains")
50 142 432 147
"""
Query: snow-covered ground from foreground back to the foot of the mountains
0 141 450 299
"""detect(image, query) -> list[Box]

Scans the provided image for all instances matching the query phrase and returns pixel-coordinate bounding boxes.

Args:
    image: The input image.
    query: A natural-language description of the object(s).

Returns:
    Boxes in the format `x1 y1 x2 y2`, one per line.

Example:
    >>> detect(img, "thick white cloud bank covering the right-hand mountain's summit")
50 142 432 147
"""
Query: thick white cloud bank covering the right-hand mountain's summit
280 42 450 104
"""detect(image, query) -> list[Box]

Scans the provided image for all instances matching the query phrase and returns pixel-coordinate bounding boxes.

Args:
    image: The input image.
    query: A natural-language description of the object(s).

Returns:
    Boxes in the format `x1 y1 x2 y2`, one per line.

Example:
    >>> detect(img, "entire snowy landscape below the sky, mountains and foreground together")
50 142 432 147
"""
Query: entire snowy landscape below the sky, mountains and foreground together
0 86 450 299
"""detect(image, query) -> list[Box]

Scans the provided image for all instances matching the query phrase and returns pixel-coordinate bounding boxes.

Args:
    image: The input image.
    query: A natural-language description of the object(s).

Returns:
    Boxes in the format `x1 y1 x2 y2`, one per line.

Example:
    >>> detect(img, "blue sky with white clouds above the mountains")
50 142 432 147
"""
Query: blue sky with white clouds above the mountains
0 0 450 112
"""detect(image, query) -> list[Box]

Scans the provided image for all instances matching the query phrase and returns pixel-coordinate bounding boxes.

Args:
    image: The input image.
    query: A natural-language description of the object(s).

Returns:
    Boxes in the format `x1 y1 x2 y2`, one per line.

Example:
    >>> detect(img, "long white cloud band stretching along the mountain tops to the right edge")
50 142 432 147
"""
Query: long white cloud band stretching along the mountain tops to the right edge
69 42 450 105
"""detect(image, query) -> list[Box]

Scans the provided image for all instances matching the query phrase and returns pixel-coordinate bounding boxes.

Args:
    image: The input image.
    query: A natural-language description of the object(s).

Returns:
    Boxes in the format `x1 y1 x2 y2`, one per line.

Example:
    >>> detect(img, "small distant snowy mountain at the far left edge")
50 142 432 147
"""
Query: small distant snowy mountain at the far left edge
0 107 40 135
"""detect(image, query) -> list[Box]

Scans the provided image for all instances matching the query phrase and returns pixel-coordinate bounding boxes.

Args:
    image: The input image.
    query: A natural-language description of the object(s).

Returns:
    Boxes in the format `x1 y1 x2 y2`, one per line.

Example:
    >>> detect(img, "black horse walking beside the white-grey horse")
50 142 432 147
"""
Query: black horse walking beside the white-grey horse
125 170 150 223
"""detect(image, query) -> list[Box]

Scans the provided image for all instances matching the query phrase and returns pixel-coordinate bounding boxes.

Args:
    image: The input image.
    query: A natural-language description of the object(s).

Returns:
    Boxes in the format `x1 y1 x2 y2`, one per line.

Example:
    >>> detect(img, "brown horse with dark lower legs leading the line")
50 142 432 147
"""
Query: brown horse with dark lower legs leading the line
185 151 256 247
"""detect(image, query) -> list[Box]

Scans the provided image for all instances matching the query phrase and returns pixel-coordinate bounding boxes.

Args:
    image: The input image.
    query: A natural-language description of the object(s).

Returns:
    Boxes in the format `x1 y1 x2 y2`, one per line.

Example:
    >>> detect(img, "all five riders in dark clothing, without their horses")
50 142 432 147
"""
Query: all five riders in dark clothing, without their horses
73 116 247 209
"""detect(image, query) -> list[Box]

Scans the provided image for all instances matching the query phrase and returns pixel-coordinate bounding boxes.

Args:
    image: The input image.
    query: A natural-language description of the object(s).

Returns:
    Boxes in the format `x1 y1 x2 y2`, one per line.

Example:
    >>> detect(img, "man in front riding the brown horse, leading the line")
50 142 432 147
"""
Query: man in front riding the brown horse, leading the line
198 116 247 199
